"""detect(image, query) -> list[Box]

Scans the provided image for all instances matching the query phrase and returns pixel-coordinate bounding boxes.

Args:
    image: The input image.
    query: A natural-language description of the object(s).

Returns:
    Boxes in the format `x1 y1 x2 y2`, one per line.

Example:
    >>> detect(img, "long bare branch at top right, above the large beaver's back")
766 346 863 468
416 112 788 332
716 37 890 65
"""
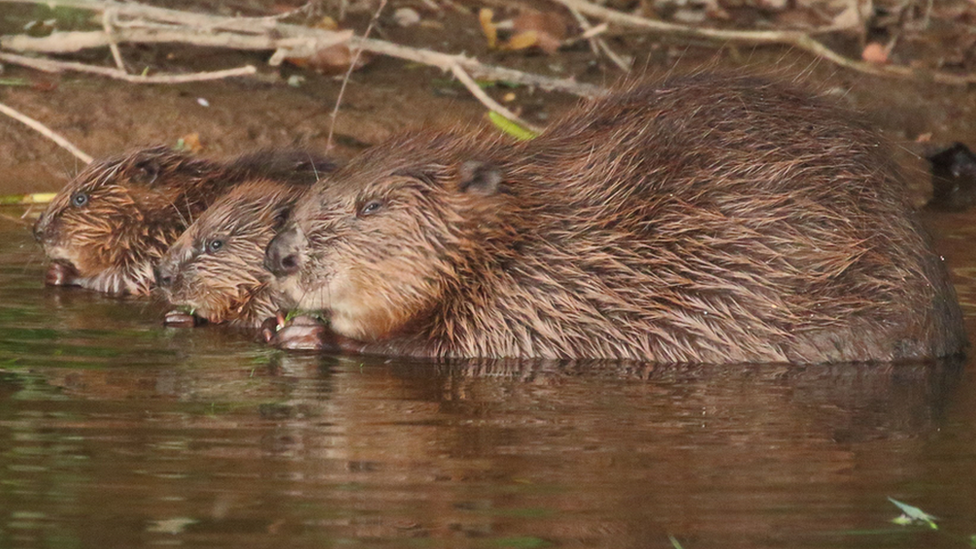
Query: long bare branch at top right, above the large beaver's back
556 0 976 86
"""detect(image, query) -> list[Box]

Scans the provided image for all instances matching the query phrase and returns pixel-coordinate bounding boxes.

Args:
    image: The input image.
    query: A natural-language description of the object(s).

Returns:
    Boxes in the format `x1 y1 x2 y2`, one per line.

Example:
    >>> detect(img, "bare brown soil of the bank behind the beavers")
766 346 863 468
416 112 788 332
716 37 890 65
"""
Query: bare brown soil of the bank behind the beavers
0 1 976 202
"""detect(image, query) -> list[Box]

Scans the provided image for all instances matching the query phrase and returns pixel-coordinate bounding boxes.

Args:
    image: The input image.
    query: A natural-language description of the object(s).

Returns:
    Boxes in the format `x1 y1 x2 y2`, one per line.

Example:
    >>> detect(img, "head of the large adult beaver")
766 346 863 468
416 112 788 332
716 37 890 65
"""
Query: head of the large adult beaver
265 133 510 341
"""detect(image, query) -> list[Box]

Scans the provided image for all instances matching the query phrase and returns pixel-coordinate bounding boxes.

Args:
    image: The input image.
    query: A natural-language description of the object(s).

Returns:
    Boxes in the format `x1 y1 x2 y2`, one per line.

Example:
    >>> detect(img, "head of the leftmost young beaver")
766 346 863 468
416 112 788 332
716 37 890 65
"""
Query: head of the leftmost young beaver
34 147 233 294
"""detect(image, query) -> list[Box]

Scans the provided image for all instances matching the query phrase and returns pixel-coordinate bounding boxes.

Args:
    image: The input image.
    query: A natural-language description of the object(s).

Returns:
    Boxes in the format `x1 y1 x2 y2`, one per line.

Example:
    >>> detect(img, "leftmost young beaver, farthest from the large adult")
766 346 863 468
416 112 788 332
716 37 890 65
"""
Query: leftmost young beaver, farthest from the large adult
34 147 335 295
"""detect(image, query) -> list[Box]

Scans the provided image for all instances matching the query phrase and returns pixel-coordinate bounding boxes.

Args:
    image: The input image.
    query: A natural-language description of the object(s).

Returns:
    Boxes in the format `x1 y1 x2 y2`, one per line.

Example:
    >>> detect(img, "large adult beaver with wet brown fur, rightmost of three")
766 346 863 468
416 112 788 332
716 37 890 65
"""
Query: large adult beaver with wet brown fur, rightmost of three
266 74 966 364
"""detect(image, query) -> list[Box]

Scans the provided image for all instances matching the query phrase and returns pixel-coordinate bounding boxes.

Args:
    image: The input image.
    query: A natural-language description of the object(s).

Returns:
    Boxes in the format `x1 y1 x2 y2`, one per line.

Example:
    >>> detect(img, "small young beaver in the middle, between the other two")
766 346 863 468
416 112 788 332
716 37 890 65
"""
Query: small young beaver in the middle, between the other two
156 180 306 328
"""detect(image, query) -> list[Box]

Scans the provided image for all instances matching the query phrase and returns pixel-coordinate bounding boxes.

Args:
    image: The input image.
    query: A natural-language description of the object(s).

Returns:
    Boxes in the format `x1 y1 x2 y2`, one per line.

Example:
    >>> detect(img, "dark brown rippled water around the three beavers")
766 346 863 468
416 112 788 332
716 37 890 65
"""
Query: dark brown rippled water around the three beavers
0 212 976 549
